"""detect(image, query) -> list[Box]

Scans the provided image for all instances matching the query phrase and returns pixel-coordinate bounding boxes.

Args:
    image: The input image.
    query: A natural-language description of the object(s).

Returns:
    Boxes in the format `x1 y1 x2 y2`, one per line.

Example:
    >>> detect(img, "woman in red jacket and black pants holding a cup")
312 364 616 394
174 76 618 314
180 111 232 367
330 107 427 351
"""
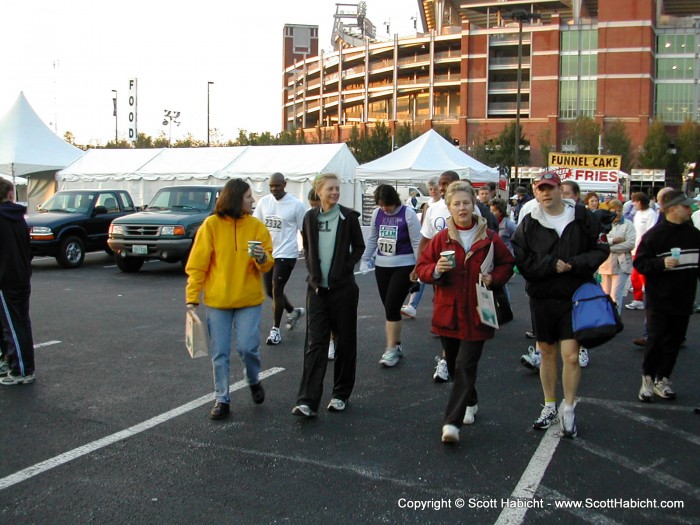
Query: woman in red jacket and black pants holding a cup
416 181 513 443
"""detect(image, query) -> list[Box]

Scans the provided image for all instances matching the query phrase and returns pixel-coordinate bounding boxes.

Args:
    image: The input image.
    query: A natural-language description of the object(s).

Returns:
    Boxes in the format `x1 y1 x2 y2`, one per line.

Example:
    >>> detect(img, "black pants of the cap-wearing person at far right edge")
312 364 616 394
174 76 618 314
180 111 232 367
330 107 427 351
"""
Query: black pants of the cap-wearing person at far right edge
642 308 690 379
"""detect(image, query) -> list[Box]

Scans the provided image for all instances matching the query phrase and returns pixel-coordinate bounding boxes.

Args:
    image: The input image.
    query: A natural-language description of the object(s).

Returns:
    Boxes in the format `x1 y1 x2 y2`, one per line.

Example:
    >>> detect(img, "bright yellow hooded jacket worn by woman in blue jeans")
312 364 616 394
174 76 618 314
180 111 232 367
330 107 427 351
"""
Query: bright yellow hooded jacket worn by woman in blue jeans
185 215 274 309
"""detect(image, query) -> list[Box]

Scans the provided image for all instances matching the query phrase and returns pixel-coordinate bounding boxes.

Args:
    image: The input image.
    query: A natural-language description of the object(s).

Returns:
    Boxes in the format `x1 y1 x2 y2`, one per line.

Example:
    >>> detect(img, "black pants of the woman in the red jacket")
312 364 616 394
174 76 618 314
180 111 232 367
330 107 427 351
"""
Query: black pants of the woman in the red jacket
441 337 485 428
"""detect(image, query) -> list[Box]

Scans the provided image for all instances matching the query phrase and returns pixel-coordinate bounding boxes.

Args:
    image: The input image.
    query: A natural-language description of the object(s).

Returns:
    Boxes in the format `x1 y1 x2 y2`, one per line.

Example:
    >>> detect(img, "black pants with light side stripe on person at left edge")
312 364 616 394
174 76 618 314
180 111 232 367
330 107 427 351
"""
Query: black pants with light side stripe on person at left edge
0 288 34 376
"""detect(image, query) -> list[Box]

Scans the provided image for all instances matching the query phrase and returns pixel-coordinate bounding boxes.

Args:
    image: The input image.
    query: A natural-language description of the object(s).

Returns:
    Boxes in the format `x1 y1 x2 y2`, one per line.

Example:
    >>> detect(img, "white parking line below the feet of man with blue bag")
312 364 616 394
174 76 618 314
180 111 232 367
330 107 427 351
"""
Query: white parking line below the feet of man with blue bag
496 423 561 525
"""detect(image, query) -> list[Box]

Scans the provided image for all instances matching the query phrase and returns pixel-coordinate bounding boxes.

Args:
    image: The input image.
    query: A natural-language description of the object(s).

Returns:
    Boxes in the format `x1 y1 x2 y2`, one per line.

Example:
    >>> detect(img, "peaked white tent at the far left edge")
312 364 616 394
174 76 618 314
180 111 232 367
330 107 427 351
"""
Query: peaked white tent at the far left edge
0 93 83 206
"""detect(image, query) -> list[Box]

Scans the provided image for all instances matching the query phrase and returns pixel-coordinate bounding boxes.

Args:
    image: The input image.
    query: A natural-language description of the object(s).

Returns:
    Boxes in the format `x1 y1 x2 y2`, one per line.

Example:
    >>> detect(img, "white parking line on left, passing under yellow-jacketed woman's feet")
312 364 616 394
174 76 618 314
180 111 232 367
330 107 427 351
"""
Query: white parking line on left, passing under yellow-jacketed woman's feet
0 367 284 490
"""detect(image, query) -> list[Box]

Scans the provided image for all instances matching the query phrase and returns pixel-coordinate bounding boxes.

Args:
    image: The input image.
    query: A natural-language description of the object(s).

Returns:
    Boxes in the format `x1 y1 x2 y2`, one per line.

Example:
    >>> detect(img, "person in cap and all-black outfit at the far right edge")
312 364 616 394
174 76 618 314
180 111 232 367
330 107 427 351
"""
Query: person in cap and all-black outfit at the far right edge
634 190 700 402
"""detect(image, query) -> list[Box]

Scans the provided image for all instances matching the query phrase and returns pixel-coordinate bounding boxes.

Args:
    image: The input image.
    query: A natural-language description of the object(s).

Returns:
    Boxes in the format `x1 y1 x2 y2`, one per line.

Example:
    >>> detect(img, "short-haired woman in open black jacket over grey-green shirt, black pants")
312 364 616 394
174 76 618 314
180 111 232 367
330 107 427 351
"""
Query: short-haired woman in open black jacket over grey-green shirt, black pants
292 173 365 418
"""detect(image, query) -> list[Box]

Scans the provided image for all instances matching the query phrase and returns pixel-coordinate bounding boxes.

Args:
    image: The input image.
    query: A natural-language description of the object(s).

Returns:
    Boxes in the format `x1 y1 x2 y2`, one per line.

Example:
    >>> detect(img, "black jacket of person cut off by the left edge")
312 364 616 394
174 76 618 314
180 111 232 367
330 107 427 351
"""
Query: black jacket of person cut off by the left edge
0 201 32 290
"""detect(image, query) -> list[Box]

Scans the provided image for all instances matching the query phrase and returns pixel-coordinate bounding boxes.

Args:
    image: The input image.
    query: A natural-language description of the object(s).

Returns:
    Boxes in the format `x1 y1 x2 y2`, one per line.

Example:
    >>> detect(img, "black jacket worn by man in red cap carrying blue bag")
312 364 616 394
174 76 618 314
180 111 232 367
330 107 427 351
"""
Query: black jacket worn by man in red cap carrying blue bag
512 204 610 299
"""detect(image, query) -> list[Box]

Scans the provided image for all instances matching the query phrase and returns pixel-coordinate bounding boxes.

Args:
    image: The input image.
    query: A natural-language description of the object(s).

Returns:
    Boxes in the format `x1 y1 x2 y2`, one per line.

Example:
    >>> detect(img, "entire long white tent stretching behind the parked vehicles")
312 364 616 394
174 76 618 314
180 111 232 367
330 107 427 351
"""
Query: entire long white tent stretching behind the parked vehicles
56 144 357 206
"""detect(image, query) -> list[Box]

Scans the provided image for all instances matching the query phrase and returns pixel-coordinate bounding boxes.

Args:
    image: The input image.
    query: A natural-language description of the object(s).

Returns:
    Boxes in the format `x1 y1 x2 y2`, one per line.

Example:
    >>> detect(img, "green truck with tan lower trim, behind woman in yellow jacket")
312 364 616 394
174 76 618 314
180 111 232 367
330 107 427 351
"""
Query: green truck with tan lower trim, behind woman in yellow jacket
107 186 223 273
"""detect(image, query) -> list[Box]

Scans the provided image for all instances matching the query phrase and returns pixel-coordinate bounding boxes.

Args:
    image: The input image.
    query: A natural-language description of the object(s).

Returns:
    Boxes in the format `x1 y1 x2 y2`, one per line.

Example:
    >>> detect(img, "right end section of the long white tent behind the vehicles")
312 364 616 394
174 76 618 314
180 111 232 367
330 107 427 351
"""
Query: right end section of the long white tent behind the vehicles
218 143 357 207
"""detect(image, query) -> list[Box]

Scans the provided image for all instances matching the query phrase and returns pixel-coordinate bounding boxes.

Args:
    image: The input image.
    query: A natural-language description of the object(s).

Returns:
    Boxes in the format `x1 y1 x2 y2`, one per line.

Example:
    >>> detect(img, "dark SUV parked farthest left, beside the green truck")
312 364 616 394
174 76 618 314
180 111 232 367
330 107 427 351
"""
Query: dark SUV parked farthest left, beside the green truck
27 190 136 268
